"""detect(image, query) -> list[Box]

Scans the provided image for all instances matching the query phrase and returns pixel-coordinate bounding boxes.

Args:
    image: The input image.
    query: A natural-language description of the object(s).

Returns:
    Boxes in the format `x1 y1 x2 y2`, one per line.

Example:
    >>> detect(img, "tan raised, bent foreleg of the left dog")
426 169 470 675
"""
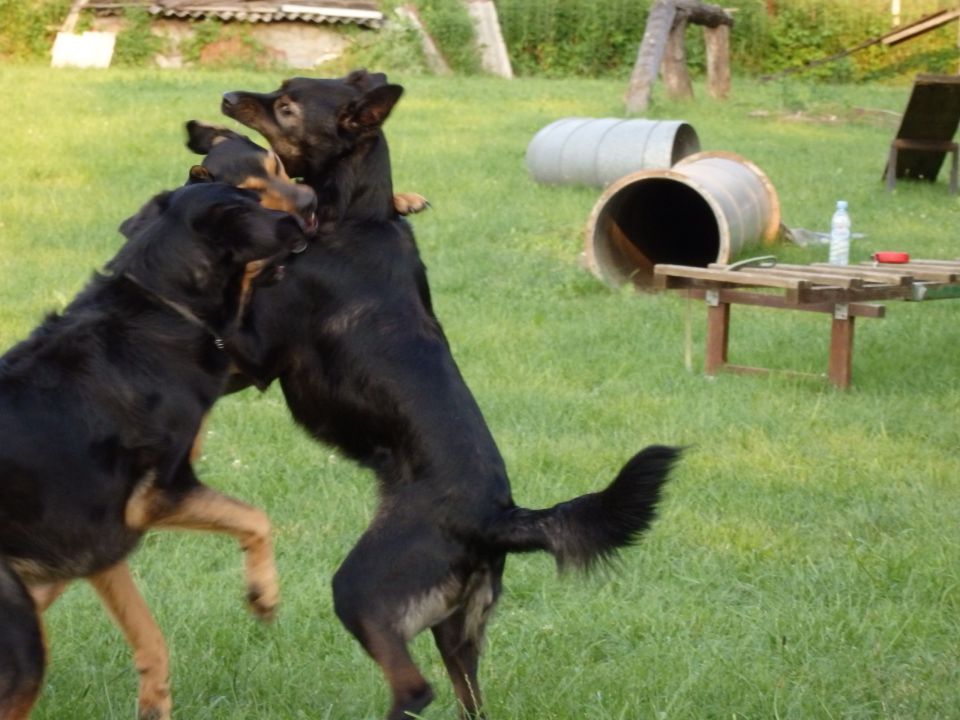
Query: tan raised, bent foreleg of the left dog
126 482 280 620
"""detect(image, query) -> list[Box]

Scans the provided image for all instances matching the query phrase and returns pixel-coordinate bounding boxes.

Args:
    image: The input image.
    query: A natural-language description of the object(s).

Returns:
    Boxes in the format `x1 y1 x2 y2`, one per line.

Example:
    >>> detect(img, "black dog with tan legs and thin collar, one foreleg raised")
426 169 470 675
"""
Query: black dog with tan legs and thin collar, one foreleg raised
0 183 305 720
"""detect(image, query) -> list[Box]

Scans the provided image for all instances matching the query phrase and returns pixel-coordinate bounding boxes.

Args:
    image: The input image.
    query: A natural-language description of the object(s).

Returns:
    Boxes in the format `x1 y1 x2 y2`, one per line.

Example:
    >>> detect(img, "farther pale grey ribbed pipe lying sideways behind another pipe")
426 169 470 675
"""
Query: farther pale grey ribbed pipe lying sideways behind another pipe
527 118 700 186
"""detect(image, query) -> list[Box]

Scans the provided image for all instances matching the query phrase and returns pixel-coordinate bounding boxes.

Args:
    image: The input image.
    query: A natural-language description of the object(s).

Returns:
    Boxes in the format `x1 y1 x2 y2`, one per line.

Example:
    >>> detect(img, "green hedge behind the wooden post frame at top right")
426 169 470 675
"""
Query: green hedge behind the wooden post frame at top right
497 0 960 80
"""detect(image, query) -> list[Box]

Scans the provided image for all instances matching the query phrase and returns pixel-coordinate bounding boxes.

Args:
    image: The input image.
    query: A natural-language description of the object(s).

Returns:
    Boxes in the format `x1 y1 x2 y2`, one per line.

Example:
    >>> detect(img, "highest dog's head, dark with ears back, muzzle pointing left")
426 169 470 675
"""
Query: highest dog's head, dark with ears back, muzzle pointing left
221 70 403 177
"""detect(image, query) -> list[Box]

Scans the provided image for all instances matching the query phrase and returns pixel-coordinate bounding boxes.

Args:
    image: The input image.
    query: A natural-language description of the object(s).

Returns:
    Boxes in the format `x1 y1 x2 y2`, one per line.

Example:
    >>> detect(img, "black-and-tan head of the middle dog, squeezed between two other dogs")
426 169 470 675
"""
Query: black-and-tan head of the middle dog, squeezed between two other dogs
186 120 317 232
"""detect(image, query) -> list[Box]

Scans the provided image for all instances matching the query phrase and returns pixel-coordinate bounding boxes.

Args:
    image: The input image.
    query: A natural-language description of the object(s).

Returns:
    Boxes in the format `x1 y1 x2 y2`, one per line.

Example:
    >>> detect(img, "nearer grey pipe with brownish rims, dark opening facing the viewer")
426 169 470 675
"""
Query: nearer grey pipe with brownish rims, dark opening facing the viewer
586 152 780 288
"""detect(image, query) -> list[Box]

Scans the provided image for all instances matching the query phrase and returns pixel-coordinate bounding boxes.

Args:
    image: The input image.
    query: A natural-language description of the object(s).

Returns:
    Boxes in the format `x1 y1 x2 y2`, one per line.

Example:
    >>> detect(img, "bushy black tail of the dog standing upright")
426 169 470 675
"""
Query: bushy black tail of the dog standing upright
487 445 681 569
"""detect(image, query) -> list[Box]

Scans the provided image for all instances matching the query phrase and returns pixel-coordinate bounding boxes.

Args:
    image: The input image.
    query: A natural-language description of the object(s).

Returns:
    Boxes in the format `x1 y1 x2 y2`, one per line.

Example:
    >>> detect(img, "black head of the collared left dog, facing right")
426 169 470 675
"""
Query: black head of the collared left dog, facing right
107 182 306 316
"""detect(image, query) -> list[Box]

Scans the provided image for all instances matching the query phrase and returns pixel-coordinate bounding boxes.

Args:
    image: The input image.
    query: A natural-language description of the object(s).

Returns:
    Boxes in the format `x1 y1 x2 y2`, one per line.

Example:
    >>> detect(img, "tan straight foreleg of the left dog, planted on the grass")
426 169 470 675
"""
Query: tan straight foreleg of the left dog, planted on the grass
87 562 172 720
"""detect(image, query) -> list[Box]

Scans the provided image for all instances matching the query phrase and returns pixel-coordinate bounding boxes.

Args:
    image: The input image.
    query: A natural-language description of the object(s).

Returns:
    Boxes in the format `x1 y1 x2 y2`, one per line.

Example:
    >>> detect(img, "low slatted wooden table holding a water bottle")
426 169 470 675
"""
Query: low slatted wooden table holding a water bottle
654 260 960 389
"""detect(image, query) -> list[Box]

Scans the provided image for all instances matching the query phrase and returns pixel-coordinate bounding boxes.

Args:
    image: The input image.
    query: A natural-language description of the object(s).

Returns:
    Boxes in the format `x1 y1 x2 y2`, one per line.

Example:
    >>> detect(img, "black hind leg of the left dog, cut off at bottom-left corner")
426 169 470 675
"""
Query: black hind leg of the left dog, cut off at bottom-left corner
0 558 46 720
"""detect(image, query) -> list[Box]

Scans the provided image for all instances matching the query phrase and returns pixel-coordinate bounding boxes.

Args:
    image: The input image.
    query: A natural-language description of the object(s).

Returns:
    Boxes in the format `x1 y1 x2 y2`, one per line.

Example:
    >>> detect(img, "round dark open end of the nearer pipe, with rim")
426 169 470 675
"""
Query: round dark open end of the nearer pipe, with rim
593 177 720 287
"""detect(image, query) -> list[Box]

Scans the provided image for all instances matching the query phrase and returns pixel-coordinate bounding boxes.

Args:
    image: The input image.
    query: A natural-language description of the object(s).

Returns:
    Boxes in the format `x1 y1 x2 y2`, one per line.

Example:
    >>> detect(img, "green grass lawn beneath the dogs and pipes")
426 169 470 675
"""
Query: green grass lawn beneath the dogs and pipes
0 67 960 720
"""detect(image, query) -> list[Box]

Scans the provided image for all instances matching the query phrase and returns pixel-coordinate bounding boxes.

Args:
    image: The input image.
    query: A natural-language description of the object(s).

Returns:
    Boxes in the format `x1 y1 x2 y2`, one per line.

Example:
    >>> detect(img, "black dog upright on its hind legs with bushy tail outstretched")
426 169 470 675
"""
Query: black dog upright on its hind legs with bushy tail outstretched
222 71 679 720
